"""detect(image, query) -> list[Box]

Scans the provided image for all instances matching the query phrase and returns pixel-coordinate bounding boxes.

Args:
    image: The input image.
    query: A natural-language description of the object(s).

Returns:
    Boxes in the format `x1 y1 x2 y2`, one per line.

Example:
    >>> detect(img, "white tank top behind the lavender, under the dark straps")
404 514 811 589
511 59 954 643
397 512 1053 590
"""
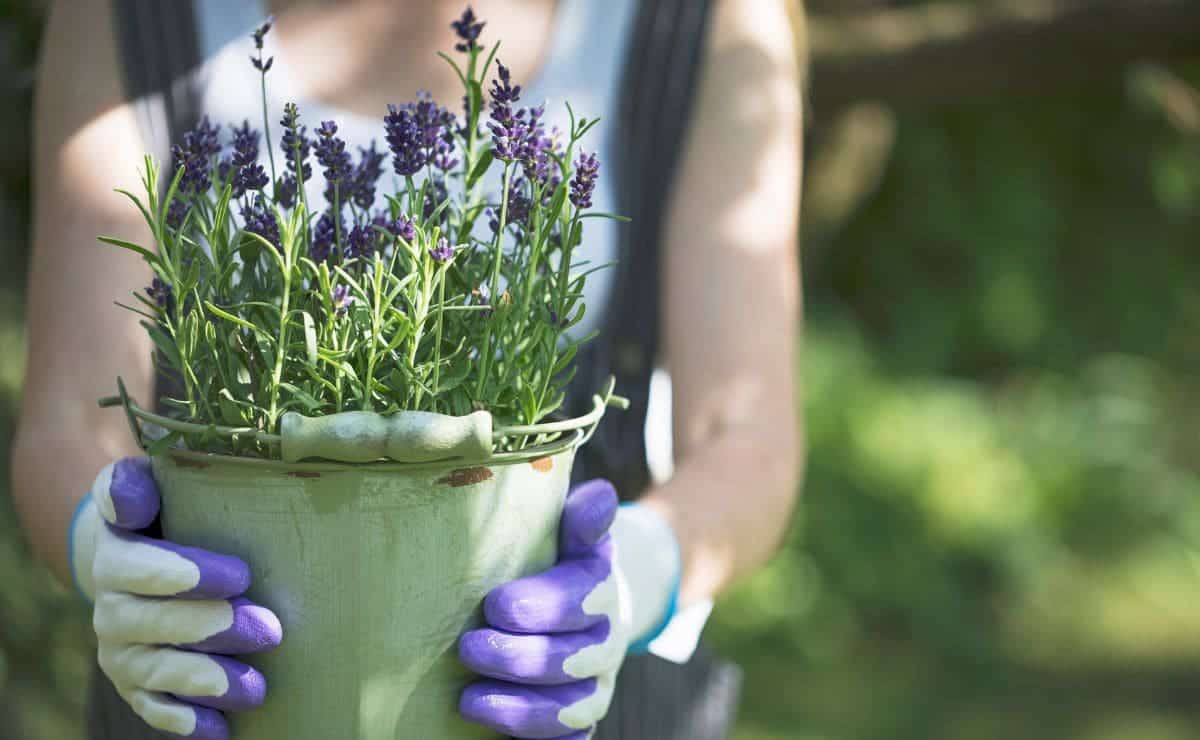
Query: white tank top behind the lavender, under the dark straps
189 0 636 335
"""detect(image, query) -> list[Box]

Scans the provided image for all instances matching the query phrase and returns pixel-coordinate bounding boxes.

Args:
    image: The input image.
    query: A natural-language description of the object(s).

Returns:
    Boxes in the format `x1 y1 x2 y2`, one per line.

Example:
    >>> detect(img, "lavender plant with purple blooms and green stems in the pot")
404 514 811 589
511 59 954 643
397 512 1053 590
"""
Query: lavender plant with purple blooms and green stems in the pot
101 8 619 457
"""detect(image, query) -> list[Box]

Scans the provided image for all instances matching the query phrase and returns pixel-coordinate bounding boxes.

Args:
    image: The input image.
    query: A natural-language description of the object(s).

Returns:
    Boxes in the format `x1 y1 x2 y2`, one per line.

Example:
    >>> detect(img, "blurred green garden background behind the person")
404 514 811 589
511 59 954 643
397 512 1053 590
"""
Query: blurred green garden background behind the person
0 0 1200 740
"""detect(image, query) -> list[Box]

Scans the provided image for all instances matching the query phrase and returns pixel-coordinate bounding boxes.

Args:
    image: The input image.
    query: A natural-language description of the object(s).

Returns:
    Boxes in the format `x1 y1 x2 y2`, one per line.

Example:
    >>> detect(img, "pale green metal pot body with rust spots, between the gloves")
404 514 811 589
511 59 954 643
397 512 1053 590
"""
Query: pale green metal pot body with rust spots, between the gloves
152 435 581 740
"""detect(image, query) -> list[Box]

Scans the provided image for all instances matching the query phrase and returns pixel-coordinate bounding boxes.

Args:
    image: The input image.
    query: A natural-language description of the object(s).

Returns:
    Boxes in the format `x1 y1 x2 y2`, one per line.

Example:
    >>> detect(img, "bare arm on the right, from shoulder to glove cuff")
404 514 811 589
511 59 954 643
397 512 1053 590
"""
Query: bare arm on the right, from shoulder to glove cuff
643 0 804 606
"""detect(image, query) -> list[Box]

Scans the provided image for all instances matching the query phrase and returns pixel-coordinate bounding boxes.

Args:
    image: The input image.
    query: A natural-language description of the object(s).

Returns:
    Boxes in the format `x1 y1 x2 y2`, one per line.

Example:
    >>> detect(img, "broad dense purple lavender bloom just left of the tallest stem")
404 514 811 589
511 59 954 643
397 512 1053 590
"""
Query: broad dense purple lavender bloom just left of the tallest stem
383 92 458 178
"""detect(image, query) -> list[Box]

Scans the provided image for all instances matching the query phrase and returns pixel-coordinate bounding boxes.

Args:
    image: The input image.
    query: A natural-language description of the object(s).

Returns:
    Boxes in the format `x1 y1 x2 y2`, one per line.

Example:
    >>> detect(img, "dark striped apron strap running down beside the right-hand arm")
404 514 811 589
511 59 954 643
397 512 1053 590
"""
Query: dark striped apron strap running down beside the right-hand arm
566 0 713 498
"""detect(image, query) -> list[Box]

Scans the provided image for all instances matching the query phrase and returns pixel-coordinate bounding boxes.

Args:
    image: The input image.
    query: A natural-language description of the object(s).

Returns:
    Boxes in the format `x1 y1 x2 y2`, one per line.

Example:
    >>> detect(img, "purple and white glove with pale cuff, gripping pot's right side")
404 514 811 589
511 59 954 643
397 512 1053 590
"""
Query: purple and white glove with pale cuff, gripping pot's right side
458 480 680 740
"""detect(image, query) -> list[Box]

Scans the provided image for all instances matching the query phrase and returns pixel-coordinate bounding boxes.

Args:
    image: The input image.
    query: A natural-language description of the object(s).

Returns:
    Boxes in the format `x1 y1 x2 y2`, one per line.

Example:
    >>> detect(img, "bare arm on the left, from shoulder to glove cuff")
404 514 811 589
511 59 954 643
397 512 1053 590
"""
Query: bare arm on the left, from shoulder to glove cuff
12 2 152 583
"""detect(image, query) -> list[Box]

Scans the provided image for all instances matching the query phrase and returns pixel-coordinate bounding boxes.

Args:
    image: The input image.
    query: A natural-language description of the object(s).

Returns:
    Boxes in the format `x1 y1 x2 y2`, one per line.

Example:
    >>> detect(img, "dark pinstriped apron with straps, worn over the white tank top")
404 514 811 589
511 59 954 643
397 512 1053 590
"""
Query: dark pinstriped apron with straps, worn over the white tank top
88 0 742 740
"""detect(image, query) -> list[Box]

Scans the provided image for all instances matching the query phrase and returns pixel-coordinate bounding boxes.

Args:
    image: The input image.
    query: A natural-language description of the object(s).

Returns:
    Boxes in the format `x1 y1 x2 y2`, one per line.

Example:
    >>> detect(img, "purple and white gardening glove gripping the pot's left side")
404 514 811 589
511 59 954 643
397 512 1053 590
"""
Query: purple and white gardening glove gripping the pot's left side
68 457 283 740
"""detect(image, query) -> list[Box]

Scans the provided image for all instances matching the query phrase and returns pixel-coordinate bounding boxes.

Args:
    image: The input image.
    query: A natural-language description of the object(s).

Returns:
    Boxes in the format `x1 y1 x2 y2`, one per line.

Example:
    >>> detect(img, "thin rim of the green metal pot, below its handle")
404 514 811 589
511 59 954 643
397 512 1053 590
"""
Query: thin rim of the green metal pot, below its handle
156 429 589 473
